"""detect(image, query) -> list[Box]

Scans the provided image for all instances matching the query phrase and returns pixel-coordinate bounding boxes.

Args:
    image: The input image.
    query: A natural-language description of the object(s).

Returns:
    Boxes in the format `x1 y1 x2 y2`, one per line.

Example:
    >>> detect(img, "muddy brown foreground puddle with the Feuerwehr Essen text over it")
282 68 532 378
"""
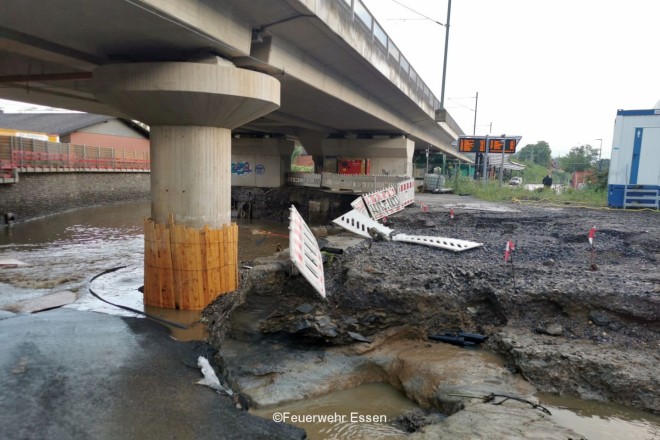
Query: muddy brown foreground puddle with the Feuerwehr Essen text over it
251 383 417 440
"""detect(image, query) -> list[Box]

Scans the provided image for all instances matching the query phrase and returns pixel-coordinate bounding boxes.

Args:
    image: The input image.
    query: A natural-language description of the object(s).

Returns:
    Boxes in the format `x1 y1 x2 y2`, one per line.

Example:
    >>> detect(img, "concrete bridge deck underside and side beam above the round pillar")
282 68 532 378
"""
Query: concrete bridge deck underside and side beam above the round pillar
0 0 469 160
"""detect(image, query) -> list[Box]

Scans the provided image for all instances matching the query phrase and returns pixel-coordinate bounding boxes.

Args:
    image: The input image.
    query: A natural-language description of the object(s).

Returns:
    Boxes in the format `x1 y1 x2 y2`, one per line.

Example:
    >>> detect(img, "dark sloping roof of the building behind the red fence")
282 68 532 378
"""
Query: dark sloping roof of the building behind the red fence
0 112 148 136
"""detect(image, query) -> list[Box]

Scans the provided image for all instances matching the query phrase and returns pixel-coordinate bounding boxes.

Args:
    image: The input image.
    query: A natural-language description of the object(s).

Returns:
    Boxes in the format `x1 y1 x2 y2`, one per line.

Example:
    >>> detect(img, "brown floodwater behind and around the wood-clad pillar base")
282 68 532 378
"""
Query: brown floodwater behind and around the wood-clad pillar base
0 202 288 340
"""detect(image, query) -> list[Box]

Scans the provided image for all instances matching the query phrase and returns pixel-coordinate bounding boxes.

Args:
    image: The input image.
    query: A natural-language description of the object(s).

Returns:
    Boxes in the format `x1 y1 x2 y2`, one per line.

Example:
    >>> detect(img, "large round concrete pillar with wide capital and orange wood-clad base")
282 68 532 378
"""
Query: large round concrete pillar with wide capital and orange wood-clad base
93 58 280 310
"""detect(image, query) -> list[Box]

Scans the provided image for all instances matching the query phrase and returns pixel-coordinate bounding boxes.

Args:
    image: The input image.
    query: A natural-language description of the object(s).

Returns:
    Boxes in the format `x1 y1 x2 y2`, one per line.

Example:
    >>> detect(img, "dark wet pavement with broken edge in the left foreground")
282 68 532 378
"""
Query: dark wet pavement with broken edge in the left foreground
0 309 305 440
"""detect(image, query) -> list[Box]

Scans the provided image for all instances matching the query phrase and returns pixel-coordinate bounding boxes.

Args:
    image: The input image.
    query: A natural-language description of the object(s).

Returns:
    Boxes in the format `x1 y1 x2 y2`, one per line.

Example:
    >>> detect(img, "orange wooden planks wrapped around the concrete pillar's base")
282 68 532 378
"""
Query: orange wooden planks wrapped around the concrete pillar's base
144 219 238 310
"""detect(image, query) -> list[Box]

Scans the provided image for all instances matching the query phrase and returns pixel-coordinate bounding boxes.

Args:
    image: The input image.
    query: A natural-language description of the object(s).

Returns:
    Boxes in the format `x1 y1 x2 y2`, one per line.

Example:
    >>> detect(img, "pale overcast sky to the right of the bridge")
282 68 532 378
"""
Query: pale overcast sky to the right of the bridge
362 0 660 157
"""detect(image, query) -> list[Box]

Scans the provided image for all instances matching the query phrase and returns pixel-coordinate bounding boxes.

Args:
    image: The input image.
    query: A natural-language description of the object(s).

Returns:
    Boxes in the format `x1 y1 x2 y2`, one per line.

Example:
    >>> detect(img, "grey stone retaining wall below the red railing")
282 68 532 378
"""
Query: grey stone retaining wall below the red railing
0 173 150 225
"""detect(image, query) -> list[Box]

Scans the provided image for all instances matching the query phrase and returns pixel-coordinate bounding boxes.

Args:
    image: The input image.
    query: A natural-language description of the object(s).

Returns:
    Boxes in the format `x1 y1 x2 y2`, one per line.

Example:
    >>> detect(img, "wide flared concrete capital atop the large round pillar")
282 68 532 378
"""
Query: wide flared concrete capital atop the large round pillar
92 58 280 129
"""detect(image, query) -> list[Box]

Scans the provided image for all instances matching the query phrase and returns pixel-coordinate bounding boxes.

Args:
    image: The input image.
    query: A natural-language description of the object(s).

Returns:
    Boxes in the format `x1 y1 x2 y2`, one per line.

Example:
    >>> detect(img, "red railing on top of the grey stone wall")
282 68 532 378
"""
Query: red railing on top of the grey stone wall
0 136 150 174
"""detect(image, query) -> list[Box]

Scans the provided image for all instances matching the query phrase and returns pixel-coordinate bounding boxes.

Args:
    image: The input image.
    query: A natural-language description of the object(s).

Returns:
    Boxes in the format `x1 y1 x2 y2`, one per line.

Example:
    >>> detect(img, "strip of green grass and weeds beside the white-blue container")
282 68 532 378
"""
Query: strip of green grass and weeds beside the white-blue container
447 176 607 208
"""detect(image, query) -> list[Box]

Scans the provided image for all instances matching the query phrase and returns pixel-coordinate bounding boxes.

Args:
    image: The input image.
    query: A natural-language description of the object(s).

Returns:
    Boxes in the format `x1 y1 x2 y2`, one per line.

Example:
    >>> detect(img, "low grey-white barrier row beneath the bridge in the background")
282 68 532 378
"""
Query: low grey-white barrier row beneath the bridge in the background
287 173 410 193
